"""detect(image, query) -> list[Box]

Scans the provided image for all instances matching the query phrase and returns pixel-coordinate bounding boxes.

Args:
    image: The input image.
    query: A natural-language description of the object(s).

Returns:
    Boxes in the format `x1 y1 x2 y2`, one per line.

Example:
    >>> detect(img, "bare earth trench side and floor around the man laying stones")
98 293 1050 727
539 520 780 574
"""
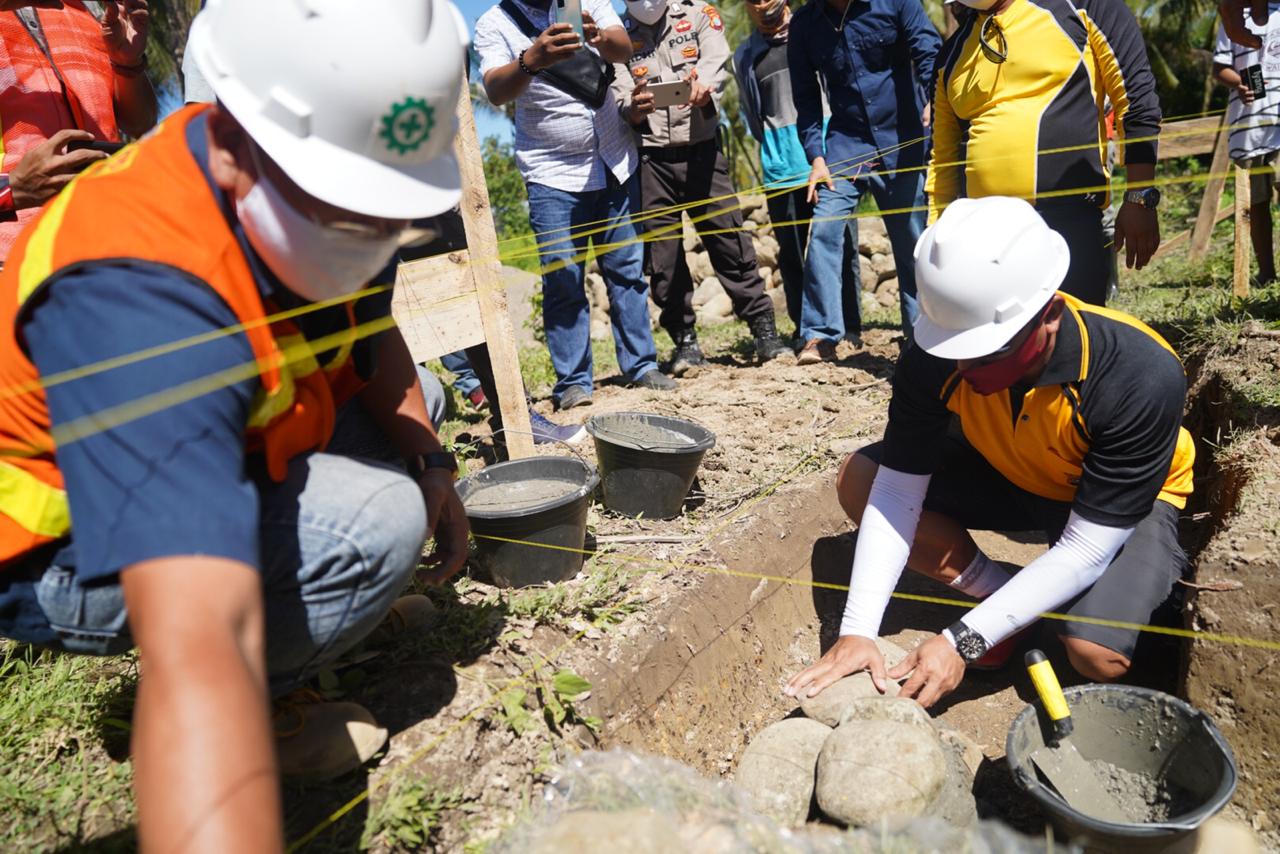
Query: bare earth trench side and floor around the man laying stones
590 471 1044 834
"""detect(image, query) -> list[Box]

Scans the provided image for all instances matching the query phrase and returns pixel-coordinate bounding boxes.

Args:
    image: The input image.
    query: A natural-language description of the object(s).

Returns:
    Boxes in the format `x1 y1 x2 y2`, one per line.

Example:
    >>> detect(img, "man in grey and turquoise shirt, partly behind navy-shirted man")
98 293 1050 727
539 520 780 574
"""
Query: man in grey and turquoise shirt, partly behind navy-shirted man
733 0 861 344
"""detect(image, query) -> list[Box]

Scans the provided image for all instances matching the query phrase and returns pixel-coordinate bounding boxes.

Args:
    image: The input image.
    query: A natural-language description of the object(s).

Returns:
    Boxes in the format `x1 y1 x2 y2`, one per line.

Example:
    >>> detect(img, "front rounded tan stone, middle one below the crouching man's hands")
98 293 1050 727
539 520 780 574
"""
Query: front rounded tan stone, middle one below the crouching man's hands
815 720 947 827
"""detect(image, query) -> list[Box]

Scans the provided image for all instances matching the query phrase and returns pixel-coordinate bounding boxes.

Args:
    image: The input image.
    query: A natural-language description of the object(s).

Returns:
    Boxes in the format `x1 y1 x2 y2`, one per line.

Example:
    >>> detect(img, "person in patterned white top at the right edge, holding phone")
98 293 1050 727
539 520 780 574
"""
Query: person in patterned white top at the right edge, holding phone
1213 1 1280 286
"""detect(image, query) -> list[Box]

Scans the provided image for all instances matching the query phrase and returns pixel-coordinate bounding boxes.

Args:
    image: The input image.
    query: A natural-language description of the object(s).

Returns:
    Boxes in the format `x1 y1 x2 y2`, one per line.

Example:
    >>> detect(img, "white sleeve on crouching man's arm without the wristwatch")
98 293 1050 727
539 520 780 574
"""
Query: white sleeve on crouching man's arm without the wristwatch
840 466 929 638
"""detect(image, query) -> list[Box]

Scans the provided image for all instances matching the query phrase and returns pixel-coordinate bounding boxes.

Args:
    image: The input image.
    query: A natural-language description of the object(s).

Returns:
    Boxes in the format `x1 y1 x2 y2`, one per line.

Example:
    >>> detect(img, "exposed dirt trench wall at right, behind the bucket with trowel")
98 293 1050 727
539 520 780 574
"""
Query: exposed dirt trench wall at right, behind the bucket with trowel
1178 335 1280 834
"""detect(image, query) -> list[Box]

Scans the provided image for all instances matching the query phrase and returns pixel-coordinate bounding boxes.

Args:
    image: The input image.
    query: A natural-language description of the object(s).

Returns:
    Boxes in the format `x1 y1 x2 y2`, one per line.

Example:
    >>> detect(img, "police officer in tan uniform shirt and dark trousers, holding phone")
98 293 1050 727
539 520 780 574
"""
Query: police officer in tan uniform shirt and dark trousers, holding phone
616 0 791 376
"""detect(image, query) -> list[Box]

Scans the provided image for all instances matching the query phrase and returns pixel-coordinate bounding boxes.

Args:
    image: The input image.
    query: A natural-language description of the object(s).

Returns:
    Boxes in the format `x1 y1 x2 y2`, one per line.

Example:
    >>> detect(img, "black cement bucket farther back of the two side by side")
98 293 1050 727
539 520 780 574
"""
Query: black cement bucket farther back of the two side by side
586 412 716 519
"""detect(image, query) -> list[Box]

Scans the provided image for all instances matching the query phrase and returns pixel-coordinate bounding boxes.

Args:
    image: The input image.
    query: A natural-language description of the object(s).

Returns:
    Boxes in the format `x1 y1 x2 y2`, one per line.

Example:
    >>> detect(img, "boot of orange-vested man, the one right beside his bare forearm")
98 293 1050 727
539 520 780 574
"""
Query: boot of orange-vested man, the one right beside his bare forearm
271 688 387 781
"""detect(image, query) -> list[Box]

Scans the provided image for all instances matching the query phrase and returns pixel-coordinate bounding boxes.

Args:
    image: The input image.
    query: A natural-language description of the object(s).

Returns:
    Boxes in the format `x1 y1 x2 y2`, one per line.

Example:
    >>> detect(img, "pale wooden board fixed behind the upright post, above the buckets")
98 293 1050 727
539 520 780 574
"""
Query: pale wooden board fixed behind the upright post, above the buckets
392 250 484 362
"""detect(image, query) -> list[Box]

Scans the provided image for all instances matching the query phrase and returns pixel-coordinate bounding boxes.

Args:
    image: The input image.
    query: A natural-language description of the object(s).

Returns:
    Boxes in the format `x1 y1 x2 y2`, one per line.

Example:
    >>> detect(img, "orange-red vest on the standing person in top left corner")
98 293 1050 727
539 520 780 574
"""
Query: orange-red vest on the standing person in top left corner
0 0 120 260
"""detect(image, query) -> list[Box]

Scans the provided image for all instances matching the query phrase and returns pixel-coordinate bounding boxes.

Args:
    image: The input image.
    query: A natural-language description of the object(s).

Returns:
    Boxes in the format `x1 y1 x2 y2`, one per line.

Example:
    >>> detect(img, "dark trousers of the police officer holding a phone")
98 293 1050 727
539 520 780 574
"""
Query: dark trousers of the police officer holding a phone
640 140 773 335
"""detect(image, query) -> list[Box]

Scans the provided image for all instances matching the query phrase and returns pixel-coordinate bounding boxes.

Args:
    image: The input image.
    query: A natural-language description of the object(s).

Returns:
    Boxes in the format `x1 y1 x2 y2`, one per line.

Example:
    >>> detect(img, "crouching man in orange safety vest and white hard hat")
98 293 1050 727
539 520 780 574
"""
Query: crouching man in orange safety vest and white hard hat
0 0 468 851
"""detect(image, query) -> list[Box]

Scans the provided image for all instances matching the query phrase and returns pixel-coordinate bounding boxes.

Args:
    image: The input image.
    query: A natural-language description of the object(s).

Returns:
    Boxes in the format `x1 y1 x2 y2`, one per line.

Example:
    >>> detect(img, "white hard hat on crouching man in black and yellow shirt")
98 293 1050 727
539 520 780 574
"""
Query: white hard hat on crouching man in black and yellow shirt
915 196 1071 359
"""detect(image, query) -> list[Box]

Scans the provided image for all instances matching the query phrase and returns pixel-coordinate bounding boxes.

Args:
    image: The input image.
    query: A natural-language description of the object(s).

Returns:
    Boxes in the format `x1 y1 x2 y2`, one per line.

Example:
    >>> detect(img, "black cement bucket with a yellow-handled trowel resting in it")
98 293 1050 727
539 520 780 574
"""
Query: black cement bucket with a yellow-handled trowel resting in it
1005 685 1236 854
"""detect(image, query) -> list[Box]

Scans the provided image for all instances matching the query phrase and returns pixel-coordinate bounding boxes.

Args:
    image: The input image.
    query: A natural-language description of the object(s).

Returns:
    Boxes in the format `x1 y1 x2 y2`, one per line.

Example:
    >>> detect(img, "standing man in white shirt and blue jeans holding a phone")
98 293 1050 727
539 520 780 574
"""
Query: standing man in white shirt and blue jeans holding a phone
475 0 676 410
